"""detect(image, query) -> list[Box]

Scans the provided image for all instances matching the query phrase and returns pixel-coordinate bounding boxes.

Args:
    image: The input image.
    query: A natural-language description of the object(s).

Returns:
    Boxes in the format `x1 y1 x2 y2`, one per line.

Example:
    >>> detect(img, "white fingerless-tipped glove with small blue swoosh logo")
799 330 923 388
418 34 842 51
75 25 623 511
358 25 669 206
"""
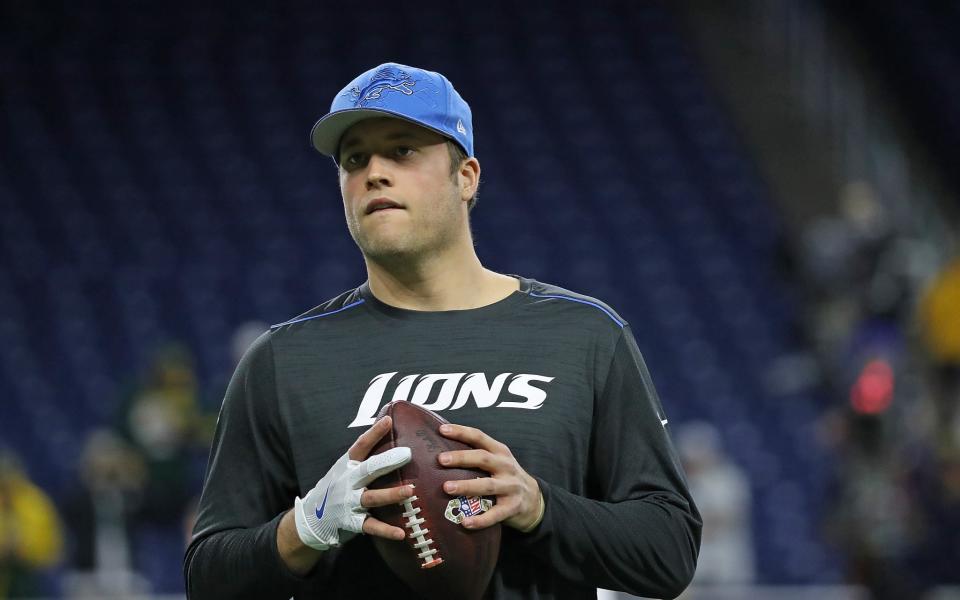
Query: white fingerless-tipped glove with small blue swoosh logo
293 447 410 550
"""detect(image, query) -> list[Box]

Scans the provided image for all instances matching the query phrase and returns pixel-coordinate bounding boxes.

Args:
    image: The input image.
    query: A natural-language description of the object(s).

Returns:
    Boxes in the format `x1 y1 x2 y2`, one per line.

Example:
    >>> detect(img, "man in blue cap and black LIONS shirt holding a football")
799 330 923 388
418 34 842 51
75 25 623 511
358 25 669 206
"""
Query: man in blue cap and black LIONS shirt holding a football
184 63 700 599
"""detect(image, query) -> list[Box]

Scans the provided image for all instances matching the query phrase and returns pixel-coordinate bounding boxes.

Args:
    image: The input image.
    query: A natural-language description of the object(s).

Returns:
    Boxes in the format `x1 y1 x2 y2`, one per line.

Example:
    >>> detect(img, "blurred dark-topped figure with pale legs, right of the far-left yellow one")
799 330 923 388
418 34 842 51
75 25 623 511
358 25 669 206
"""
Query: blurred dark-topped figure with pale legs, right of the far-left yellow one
63 430 148 598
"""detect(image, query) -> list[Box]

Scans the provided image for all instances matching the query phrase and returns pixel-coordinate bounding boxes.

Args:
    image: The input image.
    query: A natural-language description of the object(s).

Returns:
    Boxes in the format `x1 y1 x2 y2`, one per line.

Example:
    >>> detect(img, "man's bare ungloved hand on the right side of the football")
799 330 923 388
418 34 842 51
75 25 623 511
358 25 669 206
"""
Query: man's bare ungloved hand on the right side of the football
437 425 544 531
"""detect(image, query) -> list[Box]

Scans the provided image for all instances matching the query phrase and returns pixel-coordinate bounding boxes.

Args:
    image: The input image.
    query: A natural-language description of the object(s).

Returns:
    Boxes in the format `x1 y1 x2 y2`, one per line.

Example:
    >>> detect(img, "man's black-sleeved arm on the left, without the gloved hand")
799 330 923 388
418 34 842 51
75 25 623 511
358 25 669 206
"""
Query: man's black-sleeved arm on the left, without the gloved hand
184 334 308 600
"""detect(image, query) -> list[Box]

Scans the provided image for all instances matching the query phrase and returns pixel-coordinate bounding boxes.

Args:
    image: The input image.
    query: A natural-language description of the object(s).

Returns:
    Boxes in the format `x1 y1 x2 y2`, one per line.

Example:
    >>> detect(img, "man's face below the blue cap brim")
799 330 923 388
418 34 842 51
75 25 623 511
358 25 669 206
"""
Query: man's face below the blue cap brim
339 118 468 262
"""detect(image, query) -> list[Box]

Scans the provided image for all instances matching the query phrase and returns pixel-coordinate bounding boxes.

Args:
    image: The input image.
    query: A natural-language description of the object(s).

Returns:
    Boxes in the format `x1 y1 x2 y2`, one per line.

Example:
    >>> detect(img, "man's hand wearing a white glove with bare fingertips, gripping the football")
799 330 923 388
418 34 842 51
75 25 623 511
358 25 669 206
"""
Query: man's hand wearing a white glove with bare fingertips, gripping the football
293 417 413 550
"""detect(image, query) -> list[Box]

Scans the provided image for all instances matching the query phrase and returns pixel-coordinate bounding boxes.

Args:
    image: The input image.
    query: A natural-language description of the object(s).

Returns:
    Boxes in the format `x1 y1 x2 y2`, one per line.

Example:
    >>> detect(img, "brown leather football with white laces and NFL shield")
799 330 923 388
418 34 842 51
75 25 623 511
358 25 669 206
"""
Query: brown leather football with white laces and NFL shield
369 400 500 600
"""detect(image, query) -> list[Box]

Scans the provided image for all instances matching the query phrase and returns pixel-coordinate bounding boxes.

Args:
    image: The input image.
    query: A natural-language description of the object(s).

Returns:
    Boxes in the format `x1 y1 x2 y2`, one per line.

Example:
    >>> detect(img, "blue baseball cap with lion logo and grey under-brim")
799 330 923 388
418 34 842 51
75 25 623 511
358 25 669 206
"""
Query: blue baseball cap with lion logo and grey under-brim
310 63 473 160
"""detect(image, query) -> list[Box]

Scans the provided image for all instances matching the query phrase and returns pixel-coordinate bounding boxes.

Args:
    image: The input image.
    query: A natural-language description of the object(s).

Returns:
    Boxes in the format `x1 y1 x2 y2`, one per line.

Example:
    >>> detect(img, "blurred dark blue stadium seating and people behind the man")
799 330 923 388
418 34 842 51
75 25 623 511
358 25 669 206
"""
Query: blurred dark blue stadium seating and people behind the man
0 0 960 598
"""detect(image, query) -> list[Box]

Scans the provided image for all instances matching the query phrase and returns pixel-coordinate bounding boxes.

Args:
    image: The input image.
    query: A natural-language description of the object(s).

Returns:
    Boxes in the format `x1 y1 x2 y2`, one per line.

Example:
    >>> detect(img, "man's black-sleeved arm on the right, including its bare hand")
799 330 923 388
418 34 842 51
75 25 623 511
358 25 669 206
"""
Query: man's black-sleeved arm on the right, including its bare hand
445 328 701 598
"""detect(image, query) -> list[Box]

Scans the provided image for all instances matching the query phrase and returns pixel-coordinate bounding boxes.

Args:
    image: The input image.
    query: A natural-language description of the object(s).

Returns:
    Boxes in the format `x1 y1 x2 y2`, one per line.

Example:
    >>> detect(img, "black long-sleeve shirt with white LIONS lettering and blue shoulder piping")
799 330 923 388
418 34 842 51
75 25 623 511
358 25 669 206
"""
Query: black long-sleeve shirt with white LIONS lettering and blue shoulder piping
184 277 701 600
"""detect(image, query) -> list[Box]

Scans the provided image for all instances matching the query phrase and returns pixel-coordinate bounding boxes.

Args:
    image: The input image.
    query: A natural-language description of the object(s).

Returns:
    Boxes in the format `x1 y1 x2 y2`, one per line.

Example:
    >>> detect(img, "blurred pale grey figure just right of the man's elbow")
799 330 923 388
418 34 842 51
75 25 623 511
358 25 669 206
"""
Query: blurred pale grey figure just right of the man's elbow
676 421 755 585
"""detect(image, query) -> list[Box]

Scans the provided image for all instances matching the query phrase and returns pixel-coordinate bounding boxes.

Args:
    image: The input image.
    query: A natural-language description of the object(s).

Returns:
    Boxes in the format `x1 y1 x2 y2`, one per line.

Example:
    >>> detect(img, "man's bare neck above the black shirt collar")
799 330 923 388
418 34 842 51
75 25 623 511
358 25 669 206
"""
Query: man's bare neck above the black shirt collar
366 253 520 311
